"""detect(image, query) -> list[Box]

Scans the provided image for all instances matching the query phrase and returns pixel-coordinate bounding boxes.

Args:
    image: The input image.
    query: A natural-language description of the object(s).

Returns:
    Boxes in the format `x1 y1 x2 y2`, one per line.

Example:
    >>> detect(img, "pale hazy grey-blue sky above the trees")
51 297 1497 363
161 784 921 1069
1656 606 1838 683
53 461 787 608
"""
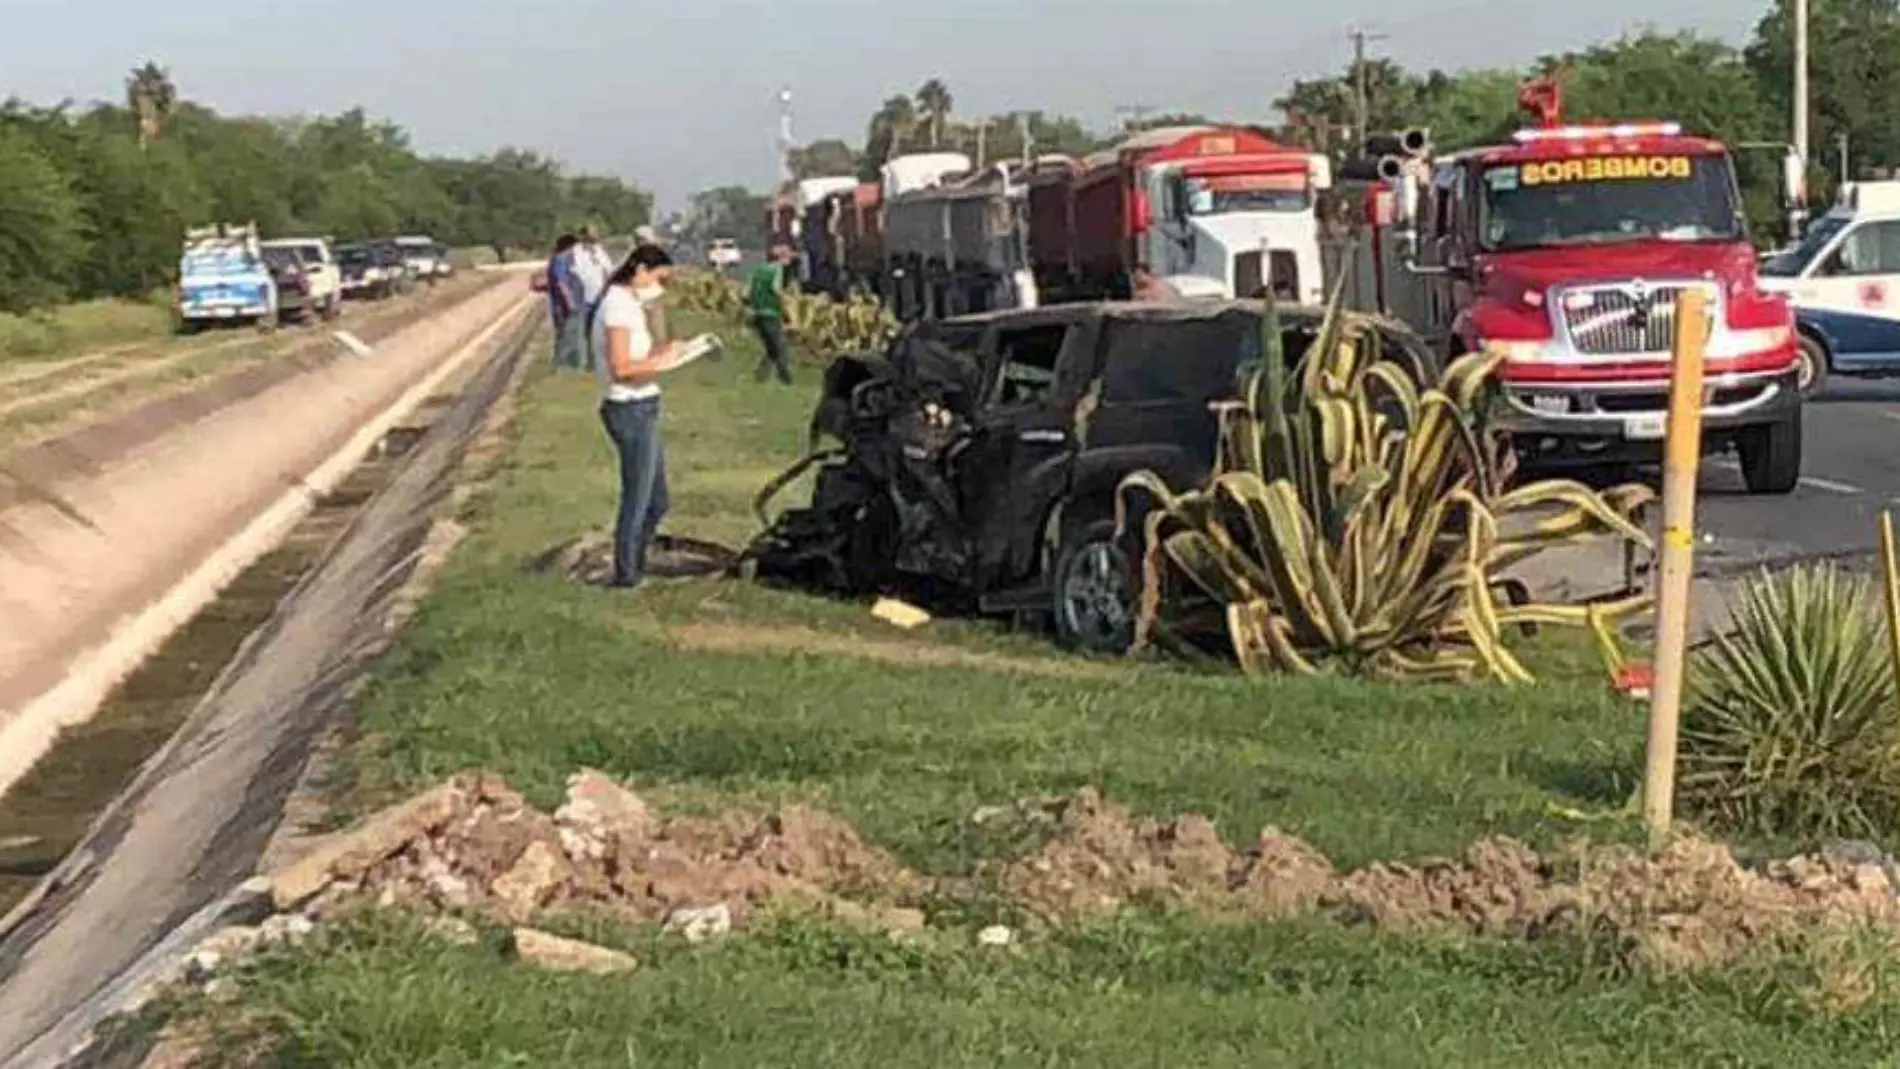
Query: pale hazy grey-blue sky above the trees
0 0 1767 209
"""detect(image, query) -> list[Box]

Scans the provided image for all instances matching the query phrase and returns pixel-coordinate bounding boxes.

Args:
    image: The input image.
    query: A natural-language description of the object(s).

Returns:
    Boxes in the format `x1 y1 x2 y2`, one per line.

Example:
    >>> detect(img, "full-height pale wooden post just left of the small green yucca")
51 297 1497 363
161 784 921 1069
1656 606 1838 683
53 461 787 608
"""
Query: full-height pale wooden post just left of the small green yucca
1644 287 1710 841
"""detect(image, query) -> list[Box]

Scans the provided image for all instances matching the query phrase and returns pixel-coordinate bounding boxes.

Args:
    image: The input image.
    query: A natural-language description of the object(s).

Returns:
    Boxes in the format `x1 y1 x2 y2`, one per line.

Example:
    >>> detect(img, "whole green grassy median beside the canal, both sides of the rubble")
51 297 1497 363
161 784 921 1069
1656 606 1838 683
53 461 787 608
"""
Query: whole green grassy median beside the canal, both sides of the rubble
167 313 1900 1067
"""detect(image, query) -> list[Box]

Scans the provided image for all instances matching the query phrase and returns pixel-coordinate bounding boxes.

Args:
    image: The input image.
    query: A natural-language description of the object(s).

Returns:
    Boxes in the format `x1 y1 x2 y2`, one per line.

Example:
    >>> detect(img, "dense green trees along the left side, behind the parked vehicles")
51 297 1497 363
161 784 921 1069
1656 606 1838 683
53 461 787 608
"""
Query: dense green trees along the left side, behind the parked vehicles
0 63 652 311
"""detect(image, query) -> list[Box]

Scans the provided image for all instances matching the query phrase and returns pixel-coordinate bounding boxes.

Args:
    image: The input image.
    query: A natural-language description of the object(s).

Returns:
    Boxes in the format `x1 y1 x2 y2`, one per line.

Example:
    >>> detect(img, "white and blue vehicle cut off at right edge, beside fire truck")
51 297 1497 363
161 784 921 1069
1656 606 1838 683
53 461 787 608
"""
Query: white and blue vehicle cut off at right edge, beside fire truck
1761 180 1900 395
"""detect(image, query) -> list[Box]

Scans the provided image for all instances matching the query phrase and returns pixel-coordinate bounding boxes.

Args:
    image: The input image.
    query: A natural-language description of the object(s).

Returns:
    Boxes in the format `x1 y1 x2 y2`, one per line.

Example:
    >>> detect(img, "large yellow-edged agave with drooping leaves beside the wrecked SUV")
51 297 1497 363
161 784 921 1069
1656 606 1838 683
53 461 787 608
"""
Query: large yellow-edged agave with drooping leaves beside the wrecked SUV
1117 286 1655 682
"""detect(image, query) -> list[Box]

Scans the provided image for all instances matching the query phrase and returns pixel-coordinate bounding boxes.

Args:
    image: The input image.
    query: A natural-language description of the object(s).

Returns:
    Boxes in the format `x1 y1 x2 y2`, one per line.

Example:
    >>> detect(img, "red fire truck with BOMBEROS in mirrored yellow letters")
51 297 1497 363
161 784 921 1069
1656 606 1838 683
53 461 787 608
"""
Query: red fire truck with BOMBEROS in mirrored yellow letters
1374 80 1801 494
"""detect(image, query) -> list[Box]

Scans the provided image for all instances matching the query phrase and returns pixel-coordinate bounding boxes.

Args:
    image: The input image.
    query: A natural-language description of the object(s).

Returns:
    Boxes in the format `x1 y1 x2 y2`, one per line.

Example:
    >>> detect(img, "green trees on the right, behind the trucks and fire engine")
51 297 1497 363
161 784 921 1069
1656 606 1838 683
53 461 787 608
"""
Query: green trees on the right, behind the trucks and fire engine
709 0 1900 244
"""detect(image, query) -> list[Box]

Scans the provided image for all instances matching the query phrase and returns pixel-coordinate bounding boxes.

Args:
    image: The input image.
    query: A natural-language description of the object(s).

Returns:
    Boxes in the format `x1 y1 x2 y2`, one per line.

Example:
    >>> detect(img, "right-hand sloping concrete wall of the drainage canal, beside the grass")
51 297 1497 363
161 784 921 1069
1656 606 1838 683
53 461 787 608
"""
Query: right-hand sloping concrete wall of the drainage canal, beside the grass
0 294 538 1069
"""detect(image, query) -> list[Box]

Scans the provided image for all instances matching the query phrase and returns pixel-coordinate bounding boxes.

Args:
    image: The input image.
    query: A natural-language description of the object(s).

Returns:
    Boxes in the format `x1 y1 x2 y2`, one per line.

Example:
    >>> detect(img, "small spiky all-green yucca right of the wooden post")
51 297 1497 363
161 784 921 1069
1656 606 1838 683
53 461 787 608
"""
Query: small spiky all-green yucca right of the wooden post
1680 564 1900 837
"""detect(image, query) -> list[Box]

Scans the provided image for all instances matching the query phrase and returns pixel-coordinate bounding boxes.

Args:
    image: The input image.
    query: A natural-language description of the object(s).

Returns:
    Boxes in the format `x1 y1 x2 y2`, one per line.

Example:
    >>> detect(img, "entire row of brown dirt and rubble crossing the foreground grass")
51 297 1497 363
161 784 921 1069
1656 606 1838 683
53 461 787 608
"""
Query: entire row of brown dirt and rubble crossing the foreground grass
279 773 1900 968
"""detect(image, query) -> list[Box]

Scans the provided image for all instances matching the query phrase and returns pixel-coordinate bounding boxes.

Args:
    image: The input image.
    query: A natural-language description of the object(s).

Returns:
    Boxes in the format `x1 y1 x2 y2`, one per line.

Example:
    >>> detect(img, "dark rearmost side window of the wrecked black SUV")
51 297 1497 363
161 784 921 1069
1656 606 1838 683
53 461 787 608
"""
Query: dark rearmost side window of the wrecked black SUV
1102 311 1260 404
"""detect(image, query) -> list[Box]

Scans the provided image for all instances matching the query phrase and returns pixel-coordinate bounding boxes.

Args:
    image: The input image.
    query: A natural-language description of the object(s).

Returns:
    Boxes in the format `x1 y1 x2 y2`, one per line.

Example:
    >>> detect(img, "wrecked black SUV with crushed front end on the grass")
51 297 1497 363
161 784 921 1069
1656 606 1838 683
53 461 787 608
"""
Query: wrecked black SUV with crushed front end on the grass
745 302 1433 653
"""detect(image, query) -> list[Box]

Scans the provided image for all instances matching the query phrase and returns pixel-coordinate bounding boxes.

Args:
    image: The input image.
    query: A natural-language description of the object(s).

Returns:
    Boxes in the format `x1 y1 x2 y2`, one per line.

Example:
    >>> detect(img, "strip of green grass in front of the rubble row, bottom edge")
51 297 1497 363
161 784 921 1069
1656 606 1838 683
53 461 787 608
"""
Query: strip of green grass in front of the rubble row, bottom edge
189 917 1896 1069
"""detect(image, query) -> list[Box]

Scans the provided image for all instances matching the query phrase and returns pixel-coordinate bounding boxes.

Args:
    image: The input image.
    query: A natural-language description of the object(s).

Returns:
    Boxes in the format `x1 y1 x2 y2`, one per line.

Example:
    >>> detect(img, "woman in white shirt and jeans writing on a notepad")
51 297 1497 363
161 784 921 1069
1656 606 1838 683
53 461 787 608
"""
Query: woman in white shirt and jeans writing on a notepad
589 245 684 589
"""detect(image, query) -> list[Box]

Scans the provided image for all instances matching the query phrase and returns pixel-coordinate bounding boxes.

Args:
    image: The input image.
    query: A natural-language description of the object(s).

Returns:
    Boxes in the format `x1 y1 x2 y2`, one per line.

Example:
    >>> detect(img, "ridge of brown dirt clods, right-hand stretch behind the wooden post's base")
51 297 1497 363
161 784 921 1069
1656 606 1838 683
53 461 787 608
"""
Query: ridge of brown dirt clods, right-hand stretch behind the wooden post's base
990 788 1900 966
